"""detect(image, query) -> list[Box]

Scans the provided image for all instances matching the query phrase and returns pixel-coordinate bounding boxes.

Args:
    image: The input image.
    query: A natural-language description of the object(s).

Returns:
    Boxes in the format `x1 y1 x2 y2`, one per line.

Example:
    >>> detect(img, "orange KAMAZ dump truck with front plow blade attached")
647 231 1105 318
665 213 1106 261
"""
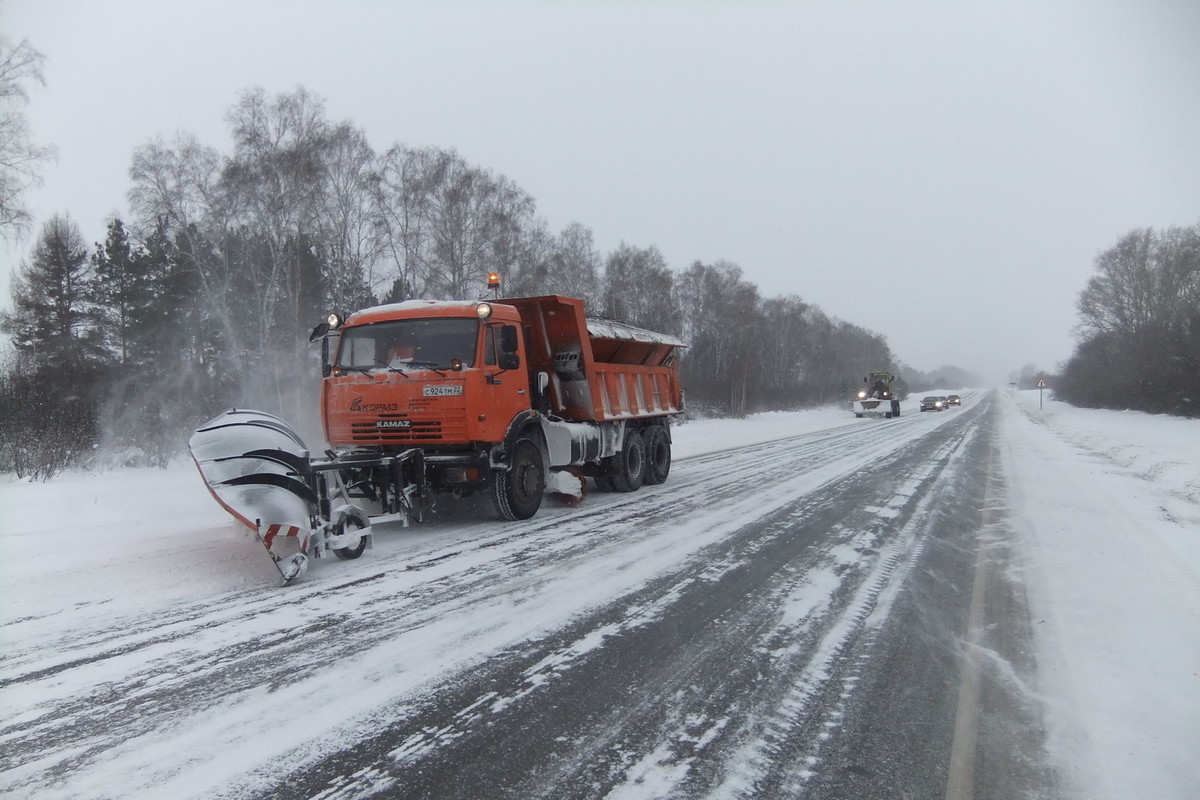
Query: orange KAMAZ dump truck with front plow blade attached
188 295 683 582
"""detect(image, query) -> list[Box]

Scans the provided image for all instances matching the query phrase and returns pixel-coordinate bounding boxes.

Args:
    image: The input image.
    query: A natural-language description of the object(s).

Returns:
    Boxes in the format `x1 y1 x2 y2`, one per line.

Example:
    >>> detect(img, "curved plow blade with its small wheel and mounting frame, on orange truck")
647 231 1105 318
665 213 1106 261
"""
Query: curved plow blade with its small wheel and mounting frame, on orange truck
187 409 420 583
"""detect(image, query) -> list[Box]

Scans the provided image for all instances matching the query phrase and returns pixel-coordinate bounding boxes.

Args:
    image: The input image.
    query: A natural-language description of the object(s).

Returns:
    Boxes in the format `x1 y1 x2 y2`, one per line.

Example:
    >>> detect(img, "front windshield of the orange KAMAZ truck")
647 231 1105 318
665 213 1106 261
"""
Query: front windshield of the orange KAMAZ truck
337 317 479 371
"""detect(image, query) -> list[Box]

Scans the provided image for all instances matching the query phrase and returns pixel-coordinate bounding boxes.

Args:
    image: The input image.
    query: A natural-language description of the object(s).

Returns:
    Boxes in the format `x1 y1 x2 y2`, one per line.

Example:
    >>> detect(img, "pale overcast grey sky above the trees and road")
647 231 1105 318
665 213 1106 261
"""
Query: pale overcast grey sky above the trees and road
0 0 1200 381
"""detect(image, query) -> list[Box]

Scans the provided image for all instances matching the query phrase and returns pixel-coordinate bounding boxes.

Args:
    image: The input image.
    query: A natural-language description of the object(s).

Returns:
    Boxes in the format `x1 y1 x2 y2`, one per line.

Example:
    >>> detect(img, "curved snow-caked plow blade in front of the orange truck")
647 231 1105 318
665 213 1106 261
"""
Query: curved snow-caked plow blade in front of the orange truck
187 409 318 583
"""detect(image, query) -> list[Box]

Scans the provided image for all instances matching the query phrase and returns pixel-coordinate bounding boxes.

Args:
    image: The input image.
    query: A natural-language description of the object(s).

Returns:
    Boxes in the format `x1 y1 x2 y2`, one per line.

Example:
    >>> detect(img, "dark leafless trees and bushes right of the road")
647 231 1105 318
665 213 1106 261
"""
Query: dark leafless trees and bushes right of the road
1052 222 1200 416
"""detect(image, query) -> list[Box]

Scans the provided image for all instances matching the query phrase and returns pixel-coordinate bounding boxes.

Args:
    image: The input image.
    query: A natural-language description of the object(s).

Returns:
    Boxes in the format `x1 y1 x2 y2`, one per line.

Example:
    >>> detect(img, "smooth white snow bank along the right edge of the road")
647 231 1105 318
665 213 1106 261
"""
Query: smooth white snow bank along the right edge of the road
1002 391 1200 800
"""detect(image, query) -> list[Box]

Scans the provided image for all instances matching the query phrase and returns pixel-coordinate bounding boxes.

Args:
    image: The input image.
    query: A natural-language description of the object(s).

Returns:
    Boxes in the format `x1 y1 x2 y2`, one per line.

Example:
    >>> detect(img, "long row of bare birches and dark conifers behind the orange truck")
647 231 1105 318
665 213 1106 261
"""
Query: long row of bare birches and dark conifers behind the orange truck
0 88 894 477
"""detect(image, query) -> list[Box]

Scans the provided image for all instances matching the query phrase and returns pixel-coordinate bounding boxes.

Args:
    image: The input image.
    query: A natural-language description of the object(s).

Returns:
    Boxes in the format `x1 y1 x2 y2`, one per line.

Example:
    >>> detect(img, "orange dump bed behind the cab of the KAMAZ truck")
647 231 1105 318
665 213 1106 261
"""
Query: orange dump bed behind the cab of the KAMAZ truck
502 295 684 422
